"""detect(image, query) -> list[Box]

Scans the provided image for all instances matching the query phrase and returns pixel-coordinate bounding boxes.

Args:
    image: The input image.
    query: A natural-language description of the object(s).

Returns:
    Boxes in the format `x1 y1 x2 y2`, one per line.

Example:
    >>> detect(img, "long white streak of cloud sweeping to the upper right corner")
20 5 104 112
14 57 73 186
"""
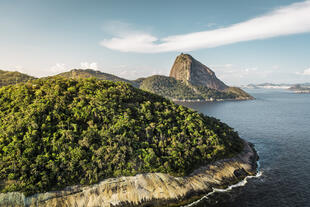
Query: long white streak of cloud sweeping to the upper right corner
100 0 310 53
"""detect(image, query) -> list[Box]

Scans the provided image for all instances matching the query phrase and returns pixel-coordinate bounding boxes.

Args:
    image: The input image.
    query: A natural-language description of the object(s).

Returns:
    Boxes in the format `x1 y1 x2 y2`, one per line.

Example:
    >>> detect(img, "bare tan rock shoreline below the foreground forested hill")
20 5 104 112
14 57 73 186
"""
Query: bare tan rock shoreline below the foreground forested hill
0 141 258 207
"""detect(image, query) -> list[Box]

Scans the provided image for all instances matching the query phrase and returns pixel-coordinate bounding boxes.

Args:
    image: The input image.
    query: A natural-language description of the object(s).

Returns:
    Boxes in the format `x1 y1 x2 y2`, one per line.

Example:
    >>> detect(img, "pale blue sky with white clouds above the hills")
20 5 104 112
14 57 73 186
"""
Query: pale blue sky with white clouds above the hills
0 0 310 86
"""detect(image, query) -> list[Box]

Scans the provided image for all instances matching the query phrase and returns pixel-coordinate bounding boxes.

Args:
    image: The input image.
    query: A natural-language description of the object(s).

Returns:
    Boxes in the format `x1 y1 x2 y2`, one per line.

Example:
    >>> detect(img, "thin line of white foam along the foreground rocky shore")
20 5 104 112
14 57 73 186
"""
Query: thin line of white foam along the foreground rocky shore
183 160 263 207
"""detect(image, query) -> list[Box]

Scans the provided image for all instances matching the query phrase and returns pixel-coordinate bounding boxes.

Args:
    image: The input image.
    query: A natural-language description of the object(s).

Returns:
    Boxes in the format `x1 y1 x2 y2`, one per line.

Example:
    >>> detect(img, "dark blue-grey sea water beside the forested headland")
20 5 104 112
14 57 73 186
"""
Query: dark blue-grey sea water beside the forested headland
178 89 310 207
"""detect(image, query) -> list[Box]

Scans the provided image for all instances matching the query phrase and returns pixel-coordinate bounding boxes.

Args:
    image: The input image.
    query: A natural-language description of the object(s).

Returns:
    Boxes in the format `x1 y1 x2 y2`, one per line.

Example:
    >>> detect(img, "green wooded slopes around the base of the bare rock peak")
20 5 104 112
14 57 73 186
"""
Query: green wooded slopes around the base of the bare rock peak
138 75 251 100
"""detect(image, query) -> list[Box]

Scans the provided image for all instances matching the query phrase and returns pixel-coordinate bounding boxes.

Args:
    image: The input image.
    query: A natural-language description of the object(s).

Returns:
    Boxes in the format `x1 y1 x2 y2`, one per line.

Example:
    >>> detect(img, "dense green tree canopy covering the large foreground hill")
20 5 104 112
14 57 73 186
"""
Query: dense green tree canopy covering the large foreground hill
0 77 243 195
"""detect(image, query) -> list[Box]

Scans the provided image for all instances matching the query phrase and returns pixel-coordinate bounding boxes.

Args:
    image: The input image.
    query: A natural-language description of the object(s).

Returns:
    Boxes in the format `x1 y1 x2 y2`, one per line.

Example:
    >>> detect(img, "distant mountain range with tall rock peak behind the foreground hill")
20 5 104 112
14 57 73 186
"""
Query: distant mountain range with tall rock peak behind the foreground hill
0 54 253 101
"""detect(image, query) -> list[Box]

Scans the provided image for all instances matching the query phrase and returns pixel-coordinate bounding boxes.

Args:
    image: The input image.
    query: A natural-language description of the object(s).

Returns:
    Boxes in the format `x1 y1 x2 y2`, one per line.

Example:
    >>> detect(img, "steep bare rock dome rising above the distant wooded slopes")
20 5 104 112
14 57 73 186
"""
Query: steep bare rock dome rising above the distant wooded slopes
170 53 228 90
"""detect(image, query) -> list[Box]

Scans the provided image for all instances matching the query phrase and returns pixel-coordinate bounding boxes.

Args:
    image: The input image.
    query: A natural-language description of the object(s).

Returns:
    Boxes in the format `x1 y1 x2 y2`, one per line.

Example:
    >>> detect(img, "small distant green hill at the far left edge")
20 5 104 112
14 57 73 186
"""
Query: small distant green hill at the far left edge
0 70 35 87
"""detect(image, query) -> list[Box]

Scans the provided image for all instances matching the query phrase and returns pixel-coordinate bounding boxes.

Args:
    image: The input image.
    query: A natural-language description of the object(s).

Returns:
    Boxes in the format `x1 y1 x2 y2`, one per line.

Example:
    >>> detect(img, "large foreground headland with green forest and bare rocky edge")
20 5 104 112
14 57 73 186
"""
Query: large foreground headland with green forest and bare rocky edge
0 77 258 206
